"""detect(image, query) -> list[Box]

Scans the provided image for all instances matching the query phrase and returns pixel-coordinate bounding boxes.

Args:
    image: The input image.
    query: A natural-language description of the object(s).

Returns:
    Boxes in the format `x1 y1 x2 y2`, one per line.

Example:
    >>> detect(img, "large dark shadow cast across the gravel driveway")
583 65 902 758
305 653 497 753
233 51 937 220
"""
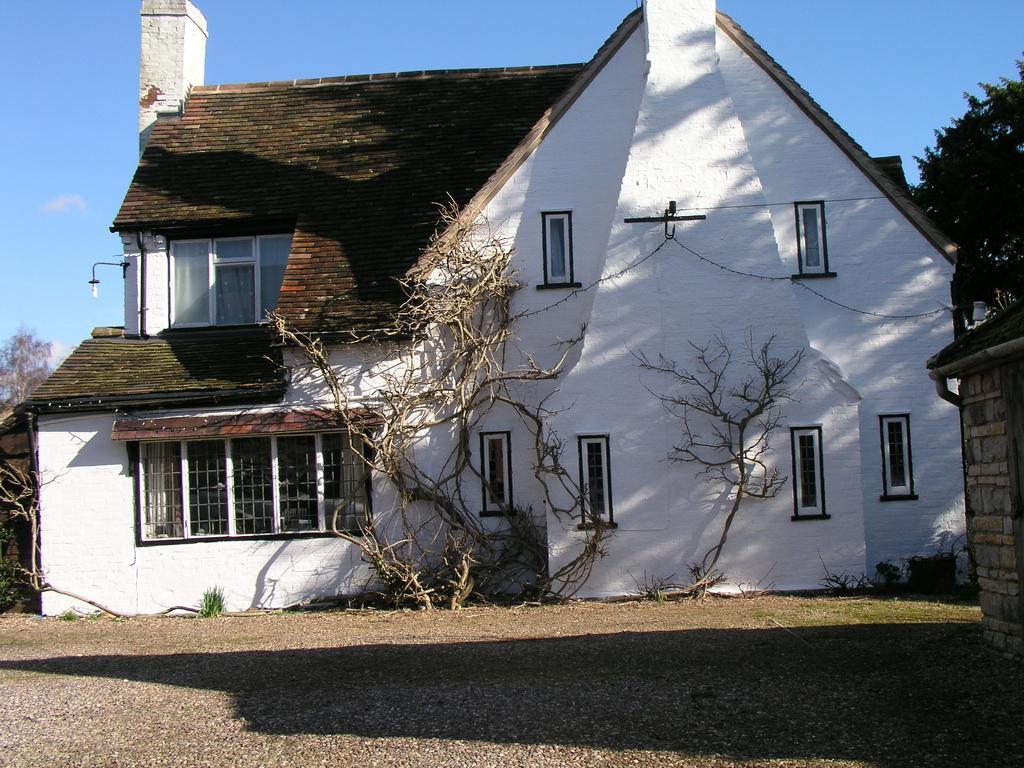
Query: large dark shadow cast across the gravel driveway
0 624 1024 766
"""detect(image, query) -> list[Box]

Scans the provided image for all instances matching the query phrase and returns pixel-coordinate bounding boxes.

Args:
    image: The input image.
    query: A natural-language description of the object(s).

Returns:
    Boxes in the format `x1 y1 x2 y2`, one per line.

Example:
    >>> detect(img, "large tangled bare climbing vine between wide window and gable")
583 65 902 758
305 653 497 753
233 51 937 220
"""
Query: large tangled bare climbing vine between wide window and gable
272 209 609 608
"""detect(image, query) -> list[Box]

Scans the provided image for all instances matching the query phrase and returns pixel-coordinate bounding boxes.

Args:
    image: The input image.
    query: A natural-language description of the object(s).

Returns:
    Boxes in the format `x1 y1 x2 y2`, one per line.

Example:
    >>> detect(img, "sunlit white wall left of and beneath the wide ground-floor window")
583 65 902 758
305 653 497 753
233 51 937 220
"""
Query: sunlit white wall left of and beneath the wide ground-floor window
39 415 370 614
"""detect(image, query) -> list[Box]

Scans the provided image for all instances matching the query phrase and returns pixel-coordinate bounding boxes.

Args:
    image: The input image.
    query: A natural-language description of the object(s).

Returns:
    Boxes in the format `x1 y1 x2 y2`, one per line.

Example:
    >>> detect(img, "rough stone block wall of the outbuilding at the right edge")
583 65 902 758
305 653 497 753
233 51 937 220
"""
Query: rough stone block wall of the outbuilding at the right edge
962 364 1024 656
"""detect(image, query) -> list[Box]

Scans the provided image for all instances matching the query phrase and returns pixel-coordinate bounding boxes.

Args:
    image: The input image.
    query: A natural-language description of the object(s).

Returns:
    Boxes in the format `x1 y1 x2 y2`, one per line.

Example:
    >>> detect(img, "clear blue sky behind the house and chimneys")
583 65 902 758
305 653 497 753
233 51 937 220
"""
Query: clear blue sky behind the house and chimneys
0 0 1024 349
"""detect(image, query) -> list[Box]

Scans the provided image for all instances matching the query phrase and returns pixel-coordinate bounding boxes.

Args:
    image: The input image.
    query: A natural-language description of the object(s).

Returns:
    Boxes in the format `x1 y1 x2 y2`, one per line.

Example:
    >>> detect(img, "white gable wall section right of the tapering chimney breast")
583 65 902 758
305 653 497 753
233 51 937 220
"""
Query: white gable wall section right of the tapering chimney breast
718 24 965 575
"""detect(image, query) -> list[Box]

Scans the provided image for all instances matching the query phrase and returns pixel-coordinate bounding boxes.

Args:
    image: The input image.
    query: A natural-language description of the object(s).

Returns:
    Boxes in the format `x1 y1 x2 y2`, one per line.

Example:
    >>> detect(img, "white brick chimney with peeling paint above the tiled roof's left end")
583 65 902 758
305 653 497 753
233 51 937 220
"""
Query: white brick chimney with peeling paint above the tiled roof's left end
138 0 207 154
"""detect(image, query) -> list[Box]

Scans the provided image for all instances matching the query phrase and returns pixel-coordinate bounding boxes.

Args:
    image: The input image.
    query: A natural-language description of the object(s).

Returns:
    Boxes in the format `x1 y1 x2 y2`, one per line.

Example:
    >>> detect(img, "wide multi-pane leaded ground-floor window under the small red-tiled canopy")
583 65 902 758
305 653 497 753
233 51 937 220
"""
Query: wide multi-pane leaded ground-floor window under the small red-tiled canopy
133 432 371 543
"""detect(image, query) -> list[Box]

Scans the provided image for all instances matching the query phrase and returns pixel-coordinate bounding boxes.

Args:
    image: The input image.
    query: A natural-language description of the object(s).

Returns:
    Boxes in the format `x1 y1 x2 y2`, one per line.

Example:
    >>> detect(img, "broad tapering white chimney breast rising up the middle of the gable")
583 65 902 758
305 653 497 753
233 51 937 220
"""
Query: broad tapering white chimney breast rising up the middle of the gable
520 2 863 595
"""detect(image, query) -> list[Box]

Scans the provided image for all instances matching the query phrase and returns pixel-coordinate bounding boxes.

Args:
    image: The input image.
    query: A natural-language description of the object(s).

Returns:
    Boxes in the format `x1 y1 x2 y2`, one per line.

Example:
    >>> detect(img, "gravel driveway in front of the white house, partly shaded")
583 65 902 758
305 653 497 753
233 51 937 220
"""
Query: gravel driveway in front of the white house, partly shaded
0 597 1024 767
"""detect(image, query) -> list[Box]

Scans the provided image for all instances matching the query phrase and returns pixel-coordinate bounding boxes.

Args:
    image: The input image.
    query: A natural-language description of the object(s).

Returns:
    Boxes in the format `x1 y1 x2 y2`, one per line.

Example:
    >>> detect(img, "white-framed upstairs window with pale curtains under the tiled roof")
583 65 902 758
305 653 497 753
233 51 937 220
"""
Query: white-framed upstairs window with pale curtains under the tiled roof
171 234 292 328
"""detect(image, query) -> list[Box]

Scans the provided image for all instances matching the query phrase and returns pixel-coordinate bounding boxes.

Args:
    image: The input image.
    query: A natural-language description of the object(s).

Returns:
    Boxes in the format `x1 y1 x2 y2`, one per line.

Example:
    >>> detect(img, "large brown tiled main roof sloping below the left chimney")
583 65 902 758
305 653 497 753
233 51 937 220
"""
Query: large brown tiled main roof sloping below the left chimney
114 65 582 331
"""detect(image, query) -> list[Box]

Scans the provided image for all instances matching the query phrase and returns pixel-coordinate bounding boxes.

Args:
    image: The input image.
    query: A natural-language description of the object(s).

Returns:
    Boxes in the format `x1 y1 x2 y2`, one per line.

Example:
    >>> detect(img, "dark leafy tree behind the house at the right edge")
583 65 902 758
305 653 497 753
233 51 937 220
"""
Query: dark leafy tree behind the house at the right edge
913 61 1024 328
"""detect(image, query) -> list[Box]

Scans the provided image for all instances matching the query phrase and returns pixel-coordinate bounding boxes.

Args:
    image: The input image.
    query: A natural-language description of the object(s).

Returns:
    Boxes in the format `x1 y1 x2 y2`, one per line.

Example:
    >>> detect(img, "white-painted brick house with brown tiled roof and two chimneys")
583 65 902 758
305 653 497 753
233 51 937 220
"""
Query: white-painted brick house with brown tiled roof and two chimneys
30 0 964 613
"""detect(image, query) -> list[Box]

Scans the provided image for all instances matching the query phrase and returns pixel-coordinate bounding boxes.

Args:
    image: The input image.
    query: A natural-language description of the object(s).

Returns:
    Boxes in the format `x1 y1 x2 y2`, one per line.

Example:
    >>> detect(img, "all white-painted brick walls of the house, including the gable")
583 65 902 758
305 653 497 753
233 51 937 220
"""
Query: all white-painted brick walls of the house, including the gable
46 0 963 612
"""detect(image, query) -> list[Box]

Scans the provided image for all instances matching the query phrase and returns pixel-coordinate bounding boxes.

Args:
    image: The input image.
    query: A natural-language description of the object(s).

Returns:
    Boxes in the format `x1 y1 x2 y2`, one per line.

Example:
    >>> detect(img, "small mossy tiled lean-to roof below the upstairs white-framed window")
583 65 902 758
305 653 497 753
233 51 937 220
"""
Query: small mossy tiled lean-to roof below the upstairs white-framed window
27 327 286 411
